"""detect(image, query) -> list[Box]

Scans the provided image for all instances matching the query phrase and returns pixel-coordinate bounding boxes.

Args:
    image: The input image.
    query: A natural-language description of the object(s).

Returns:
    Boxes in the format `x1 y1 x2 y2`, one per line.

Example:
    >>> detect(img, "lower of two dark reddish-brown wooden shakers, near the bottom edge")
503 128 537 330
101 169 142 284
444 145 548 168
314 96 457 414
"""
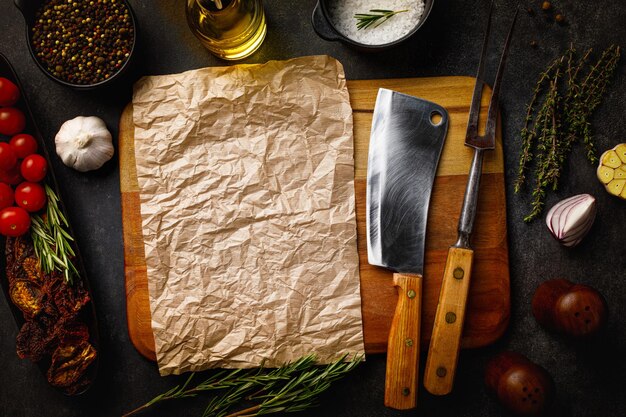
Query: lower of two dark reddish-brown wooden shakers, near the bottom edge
485 352 554 416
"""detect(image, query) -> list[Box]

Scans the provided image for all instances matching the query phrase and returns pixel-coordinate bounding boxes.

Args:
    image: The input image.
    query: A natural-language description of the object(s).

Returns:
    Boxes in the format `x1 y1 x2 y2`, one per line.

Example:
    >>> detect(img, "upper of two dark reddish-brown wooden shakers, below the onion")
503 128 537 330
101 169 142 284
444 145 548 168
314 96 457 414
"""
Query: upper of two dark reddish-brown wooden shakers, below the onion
532 279 607 338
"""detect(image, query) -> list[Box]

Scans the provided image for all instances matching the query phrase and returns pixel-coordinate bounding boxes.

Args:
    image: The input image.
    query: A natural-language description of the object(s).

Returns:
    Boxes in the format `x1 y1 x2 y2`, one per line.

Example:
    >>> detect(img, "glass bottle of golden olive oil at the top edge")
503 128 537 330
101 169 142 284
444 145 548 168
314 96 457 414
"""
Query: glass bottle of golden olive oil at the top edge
187 0 267 60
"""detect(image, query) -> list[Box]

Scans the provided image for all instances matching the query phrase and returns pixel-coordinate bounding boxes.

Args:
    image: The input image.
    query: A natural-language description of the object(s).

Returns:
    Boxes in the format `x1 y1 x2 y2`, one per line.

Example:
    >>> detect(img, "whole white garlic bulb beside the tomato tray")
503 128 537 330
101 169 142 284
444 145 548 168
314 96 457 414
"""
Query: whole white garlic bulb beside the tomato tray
54 116 114 172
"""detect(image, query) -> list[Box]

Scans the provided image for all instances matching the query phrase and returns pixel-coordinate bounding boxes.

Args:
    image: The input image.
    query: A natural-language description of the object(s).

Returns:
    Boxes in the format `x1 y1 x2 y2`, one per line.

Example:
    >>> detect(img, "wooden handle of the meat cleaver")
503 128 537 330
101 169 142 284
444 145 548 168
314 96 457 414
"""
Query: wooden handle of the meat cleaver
385 274 422 410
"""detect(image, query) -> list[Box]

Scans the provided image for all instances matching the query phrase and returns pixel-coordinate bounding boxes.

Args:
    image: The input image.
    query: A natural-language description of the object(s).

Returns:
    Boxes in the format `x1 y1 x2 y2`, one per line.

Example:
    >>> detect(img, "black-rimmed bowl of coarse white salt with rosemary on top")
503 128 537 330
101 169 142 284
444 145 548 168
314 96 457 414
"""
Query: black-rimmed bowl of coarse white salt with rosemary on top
313 0 434 51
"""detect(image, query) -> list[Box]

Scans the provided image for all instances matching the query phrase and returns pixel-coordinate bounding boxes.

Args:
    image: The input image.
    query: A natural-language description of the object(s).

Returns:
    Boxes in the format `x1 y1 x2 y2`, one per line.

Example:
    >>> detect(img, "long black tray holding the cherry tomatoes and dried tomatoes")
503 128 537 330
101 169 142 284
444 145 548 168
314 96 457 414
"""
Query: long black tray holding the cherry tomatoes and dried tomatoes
0 54 101 395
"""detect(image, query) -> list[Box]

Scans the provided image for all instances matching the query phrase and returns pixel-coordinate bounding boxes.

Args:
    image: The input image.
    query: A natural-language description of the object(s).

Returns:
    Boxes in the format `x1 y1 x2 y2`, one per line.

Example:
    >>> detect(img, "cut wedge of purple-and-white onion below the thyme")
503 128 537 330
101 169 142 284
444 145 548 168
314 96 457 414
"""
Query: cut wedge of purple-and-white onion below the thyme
546 194 596 247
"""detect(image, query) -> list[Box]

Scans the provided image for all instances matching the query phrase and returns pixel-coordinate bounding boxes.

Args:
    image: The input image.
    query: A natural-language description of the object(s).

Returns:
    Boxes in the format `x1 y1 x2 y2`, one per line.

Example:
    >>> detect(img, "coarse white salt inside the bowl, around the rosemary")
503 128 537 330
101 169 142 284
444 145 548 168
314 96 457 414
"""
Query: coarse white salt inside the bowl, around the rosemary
328 0 424 45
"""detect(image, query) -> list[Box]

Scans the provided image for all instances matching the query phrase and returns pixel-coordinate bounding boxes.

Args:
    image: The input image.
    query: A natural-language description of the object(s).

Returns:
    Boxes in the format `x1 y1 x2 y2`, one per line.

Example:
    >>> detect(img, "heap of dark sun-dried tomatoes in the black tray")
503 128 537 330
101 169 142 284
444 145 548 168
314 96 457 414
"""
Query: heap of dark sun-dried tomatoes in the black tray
5 236 97 395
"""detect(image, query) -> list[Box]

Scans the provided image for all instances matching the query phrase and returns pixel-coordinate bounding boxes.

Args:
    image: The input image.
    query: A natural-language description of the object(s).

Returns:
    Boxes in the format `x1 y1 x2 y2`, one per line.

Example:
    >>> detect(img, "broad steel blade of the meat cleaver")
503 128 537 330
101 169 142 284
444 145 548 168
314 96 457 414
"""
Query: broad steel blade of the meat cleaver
366 88 448 274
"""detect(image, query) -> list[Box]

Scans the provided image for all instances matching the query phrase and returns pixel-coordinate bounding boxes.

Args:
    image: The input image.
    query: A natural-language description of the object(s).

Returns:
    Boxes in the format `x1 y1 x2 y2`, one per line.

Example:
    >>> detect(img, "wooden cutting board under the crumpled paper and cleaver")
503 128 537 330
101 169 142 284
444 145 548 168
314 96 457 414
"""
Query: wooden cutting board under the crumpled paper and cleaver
119 77 510 360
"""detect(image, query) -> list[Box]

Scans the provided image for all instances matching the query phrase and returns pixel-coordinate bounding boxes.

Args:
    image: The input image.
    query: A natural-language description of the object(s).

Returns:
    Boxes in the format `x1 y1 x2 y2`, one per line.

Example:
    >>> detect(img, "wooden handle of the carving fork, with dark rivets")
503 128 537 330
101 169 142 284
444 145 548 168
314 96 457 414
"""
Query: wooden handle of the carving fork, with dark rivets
424 247 474 395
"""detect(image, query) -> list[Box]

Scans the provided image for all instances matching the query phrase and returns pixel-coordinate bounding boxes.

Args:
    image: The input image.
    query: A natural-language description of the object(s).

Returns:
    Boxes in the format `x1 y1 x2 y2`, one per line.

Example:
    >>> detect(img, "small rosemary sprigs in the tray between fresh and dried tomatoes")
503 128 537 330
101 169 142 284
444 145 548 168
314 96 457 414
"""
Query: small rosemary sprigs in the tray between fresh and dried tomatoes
31 184 79 284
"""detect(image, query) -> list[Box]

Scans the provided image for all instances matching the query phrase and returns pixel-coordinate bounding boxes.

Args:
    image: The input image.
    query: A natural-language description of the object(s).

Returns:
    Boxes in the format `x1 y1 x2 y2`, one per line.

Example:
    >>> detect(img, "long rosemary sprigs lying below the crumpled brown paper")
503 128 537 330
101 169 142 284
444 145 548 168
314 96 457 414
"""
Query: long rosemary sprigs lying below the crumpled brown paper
122 355 362 417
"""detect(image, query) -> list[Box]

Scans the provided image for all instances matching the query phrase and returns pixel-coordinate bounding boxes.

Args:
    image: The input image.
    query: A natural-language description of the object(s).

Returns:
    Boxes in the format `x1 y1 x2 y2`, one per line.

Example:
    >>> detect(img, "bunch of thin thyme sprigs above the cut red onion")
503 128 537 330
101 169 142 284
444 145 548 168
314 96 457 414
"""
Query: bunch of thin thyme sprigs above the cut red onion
514 45 620 222
